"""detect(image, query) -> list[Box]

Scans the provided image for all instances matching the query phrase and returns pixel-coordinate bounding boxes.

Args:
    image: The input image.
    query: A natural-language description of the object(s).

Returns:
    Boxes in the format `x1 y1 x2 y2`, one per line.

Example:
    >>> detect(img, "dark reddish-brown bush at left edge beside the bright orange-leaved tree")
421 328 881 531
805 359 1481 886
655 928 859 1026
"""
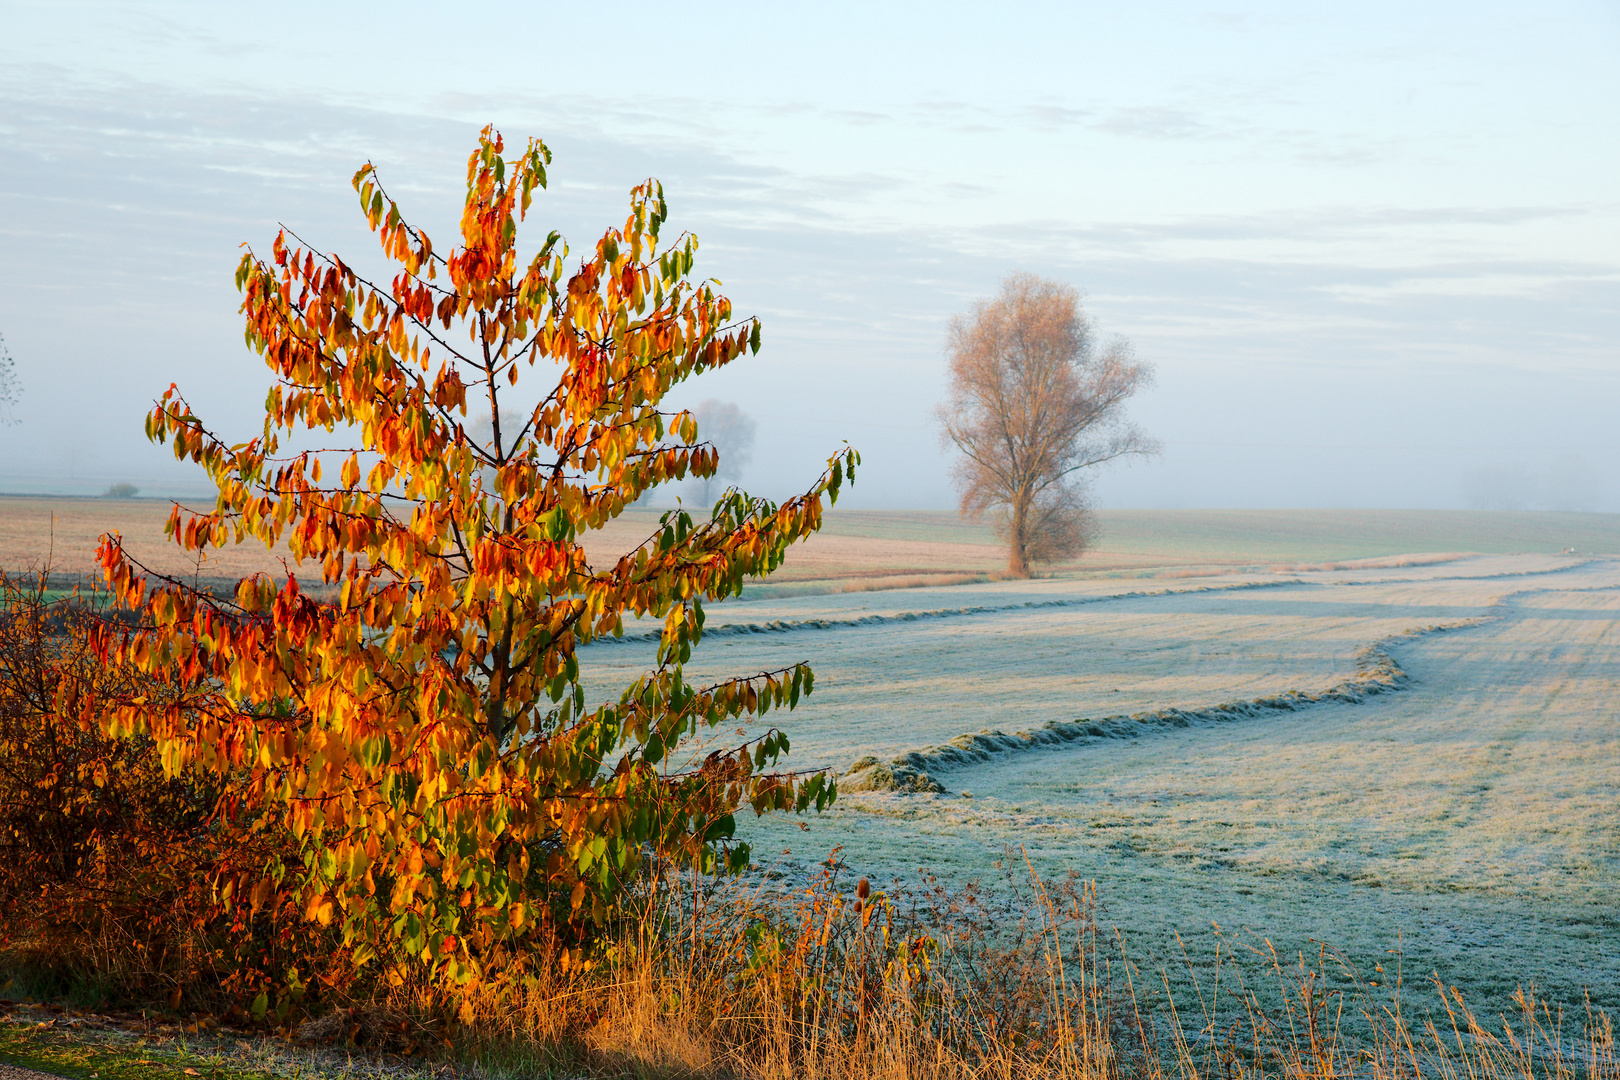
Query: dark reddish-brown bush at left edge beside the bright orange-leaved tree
0 572 353 1029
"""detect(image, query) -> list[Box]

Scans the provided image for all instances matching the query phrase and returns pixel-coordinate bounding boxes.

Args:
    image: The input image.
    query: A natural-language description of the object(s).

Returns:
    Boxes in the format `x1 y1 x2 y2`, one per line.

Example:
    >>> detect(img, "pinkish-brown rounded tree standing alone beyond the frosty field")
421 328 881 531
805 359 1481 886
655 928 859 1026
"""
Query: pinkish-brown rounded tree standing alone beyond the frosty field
938 274 1158 578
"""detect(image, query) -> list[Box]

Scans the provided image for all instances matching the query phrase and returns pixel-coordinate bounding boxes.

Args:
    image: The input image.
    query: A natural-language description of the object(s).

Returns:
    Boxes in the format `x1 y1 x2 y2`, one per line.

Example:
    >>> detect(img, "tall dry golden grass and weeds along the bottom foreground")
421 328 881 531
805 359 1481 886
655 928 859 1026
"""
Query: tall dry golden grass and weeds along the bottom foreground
392 863 1620 1080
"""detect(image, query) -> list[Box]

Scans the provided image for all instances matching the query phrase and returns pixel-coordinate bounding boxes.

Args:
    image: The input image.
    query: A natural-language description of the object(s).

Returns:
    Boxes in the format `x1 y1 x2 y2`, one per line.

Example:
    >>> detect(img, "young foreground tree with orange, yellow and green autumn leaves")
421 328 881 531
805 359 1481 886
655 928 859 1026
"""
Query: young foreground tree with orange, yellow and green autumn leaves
99 128 859 984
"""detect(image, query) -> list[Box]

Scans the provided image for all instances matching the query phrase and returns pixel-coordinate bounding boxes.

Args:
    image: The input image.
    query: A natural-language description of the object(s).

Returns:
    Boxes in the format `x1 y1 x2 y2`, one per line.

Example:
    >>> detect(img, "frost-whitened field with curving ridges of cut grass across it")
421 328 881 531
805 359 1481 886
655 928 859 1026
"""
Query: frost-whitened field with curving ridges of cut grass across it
585 555 1620 1012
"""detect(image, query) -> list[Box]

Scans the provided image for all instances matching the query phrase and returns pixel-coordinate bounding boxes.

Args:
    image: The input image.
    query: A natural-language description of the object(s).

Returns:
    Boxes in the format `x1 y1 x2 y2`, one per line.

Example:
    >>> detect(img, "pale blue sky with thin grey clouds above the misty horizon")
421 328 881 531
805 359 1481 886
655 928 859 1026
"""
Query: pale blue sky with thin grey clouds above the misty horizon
0 0 1620 512
